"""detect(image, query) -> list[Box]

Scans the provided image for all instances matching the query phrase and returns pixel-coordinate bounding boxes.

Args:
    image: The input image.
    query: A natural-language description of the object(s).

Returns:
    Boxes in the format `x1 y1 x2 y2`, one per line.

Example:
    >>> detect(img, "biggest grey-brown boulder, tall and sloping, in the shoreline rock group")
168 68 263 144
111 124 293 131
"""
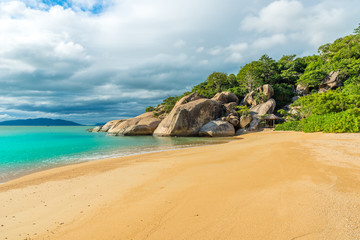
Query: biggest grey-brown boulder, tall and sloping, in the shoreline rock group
154 98 223 136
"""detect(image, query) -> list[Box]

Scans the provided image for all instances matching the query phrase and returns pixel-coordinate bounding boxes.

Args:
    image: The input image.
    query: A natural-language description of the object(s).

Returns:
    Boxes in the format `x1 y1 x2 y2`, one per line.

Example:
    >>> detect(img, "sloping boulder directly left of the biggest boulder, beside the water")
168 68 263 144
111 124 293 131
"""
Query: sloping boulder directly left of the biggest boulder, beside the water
108 112 161 136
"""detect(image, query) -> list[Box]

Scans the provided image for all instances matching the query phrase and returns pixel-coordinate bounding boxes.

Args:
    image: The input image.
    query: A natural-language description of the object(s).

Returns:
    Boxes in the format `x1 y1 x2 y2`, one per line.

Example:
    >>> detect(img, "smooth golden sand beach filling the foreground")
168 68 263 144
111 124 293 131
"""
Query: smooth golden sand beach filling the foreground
0 132 360 240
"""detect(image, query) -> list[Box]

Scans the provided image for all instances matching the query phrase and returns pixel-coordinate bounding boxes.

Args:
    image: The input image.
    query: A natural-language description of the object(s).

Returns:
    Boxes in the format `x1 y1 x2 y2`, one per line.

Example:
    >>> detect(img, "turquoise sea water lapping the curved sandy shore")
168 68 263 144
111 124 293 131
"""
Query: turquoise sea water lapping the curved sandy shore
0 126 224 183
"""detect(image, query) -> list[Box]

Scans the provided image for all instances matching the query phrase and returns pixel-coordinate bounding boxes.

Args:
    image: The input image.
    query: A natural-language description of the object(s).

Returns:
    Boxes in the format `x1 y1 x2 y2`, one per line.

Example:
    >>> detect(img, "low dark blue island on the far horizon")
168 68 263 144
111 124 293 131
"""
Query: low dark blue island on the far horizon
0 118 82 126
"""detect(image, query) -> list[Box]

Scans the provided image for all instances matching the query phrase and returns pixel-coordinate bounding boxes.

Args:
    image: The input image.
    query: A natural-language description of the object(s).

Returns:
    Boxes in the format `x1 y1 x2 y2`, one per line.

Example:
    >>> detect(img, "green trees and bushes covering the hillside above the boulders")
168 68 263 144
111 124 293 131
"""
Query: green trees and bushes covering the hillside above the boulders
147 25 360 132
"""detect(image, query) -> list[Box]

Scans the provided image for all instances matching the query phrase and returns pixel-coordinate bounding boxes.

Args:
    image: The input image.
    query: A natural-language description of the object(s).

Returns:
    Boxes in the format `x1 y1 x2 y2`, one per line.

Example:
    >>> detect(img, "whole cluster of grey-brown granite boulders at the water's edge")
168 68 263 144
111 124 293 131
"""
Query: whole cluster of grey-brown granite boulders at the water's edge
92 84 276 137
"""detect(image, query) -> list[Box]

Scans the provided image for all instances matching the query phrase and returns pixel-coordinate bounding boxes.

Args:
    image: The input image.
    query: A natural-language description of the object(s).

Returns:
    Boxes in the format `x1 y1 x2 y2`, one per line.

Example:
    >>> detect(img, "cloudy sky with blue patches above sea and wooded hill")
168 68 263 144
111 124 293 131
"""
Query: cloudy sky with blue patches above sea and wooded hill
0 0 360 124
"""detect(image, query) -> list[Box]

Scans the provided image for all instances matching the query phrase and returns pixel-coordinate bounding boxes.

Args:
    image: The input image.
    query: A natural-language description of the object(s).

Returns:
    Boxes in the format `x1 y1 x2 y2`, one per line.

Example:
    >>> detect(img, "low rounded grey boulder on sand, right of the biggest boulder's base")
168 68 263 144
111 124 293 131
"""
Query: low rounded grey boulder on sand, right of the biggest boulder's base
199 120 235 137
